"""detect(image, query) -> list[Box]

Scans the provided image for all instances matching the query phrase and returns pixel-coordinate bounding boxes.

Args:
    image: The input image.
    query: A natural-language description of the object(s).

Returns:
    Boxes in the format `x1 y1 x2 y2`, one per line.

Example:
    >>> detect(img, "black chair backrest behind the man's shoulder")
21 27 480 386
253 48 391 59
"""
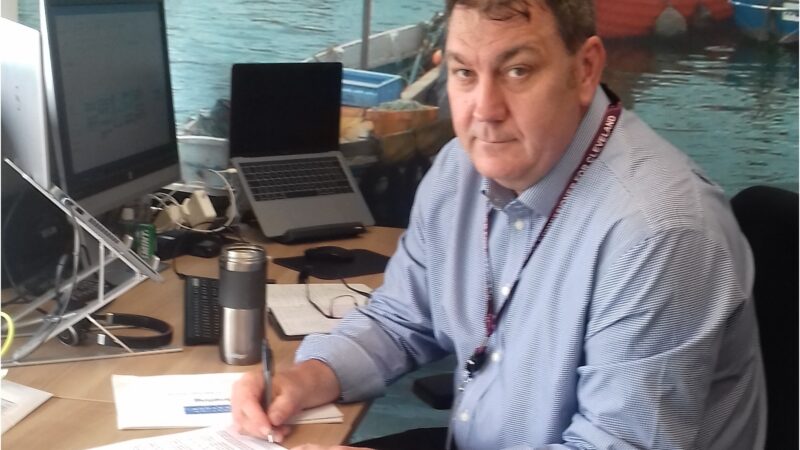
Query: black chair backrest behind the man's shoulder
731 186 800 449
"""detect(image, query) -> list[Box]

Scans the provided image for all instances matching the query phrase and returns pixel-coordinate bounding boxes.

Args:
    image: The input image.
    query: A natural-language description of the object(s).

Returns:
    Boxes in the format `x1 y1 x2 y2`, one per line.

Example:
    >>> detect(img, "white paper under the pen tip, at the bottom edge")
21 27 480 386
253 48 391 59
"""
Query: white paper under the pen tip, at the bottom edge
91 426 286 450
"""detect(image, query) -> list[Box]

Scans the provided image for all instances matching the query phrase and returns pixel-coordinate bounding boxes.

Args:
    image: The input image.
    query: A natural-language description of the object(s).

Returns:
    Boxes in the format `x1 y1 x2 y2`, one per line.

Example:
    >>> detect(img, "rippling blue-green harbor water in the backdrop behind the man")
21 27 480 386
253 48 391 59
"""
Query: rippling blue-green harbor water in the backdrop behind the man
20 0 798 195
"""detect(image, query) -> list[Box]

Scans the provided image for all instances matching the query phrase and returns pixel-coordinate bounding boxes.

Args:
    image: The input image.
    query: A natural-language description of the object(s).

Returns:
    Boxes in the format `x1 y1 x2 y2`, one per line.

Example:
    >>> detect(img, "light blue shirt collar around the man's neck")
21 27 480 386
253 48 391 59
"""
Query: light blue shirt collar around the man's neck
481 87 610 216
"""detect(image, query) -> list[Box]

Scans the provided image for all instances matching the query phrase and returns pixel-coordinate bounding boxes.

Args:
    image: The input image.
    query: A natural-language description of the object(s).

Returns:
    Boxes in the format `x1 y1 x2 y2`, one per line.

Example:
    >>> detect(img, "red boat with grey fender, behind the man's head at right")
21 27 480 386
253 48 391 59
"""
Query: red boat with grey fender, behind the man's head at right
595 0 733 38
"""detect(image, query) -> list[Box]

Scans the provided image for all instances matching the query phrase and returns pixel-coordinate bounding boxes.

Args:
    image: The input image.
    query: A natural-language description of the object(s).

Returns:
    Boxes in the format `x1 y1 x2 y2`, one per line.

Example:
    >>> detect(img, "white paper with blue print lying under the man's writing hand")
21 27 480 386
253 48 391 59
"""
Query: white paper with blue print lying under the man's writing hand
111 372 343 430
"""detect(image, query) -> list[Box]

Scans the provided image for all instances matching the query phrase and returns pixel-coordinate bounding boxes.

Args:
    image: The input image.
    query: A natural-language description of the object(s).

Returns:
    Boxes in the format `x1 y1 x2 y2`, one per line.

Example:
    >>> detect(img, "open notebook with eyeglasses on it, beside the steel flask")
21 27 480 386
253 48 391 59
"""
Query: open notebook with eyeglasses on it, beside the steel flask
267 283 372 337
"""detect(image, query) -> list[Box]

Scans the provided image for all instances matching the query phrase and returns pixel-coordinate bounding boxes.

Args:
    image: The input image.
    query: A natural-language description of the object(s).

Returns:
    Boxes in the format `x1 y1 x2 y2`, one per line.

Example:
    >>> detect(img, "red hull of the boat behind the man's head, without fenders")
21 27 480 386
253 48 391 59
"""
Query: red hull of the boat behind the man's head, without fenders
595 0 733 38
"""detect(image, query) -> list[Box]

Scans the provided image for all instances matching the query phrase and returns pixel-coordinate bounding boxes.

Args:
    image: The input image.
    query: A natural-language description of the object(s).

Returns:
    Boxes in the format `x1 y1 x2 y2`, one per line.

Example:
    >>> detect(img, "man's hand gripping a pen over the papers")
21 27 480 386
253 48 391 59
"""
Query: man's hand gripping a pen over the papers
231 360 339 442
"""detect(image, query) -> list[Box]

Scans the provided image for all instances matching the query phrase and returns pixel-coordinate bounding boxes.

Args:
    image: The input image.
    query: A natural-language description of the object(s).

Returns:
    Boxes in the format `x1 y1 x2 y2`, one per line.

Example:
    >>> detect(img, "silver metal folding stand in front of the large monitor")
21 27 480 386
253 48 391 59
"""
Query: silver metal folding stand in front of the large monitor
2 158 181 367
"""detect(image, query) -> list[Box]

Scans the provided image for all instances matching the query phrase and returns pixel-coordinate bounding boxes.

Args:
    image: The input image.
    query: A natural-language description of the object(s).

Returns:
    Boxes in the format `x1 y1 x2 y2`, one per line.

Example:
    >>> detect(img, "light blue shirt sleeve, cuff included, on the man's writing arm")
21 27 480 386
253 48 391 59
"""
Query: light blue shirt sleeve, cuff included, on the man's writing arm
295 178 445 401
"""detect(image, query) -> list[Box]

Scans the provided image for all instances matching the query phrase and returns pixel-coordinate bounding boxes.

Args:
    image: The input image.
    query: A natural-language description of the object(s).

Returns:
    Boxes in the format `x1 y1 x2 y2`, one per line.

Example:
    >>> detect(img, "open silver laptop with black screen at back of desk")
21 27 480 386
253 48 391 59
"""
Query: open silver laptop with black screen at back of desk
230 62 375 243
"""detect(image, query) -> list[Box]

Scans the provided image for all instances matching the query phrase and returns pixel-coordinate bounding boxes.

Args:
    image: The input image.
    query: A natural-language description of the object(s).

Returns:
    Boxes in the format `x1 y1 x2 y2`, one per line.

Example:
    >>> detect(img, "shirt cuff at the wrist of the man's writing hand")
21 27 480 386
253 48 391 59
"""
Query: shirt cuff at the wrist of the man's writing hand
295 334 386 402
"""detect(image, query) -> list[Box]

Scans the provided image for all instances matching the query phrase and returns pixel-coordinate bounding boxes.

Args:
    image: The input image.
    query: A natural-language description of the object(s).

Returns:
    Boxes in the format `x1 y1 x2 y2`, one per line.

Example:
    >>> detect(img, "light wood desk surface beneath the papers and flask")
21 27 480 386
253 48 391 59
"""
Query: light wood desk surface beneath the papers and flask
2 227 402 450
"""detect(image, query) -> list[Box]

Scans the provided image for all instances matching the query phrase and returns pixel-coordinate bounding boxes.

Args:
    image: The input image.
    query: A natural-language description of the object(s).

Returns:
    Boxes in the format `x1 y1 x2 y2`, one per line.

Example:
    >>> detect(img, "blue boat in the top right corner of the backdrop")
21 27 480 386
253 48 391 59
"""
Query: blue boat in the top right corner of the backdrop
731 0 798 44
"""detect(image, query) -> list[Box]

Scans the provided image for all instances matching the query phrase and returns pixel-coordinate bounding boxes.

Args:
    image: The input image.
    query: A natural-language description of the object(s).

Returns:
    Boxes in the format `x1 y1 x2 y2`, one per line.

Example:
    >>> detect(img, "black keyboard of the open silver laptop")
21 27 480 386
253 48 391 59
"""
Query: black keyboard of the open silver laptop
240 156 353 201
